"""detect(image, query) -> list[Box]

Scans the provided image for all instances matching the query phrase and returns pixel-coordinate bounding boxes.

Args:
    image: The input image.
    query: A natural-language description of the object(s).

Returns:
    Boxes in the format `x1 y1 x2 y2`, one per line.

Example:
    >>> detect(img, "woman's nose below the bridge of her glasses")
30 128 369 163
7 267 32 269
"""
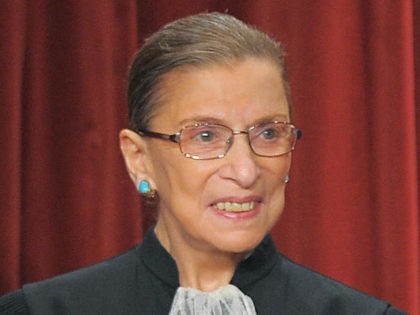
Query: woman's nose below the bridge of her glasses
220 134 260 188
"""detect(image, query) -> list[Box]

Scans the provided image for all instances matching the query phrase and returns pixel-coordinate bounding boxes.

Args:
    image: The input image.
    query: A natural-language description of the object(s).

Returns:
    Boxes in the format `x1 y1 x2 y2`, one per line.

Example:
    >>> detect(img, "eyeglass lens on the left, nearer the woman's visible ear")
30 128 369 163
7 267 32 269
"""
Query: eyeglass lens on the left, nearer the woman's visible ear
179 124 232 159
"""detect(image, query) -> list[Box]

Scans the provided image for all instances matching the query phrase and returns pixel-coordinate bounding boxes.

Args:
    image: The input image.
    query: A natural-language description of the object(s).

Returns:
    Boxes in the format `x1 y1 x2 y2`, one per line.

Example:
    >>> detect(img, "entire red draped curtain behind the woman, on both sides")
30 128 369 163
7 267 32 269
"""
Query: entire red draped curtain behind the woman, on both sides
0 0 420 314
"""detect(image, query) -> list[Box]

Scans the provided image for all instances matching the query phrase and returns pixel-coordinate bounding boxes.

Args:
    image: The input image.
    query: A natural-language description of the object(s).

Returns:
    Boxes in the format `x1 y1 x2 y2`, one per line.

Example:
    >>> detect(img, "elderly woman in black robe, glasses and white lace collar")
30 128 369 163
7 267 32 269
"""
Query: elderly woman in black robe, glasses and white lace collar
0 13 403 315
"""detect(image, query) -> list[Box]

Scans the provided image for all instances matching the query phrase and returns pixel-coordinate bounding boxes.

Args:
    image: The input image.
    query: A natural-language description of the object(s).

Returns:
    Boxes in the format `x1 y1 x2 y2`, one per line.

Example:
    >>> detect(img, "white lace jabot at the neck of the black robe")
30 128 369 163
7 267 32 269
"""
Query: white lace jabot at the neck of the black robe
169 284 257 315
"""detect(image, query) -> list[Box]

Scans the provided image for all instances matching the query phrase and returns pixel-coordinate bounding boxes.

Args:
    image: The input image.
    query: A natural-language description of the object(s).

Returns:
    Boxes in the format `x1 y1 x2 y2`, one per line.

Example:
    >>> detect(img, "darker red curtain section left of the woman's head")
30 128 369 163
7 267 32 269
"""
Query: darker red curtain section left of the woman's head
0 1 142 293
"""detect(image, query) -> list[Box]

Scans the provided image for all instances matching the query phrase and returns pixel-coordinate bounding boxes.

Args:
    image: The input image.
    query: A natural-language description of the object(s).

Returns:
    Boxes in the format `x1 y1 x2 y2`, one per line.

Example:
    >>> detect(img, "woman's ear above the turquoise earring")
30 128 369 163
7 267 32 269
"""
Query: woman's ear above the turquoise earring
119 129 150 187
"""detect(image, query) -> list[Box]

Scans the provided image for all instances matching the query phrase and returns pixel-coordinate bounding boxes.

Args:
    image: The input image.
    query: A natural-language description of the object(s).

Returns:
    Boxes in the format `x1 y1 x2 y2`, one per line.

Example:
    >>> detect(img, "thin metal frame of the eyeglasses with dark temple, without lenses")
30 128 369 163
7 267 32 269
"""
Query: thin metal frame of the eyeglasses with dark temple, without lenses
137 120 302 160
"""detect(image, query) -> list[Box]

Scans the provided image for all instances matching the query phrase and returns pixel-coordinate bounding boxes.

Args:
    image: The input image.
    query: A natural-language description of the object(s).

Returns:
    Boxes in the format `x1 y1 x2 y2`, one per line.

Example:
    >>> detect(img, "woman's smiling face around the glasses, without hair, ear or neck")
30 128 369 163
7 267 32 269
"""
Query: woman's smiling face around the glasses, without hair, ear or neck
145 58 291 253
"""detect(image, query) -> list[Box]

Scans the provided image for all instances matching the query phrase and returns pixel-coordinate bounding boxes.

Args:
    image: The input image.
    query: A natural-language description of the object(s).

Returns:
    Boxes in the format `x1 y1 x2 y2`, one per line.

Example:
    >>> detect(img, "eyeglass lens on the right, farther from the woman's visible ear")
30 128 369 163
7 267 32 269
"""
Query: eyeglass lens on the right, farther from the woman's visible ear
249 122 296 156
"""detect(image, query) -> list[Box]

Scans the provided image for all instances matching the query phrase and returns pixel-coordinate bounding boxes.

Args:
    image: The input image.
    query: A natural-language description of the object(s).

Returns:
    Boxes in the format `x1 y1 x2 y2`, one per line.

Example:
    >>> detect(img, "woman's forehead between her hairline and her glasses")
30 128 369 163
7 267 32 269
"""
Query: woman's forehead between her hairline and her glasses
149 59 289 129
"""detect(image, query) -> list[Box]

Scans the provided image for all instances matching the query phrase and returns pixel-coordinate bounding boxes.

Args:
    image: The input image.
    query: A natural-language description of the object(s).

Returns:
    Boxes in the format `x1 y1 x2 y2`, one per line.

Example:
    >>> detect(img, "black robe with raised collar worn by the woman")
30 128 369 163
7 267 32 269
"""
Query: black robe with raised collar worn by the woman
0 230 406 315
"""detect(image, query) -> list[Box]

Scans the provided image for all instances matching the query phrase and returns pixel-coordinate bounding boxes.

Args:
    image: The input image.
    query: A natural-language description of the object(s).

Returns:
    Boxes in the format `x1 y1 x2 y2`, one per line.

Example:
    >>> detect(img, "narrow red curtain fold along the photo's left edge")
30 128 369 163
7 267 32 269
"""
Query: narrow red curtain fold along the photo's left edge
0 1 26 294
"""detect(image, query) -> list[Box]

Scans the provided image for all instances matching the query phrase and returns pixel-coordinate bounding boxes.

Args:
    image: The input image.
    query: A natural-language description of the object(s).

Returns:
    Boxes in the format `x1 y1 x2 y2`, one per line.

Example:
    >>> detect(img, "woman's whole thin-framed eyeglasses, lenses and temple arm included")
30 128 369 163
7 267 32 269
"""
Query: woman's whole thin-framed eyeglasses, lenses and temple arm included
138 121 302 160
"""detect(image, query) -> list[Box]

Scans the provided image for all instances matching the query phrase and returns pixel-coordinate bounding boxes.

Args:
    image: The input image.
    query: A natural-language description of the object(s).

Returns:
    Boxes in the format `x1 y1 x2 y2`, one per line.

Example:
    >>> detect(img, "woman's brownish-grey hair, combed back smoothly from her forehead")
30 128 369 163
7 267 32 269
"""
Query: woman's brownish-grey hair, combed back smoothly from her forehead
128 12 290 131
